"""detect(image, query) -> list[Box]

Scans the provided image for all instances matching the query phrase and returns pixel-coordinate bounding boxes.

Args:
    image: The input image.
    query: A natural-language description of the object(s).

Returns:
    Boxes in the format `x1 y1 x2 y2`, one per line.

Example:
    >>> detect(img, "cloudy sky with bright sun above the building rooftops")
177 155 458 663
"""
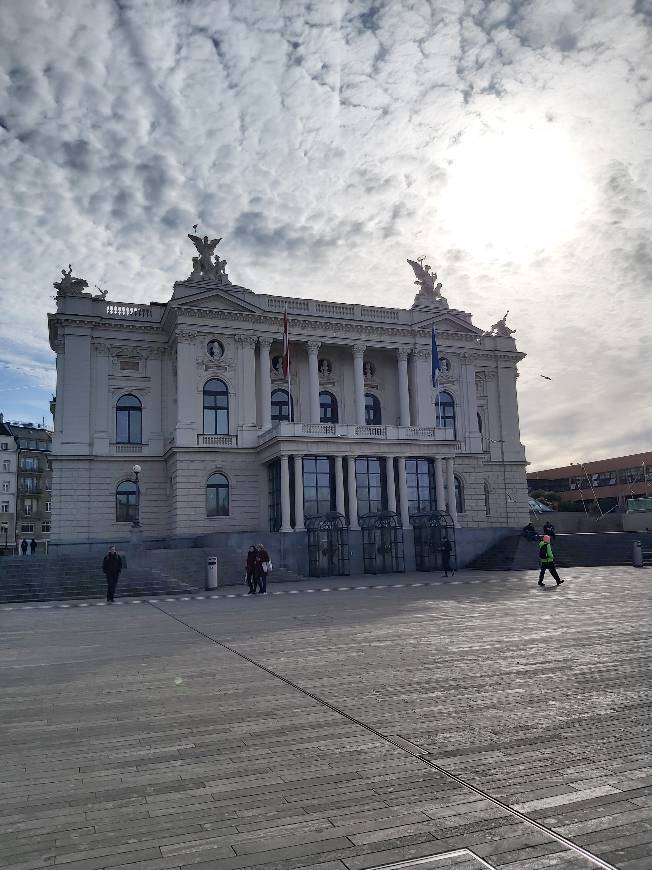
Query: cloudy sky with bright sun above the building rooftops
0 0 652 468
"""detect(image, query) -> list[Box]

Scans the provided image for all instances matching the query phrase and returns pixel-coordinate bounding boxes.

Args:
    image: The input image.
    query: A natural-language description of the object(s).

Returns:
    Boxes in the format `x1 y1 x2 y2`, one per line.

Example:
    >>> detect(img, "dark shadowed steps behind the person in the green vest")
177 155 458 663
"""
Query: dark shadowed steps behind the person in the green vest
467 532 652 571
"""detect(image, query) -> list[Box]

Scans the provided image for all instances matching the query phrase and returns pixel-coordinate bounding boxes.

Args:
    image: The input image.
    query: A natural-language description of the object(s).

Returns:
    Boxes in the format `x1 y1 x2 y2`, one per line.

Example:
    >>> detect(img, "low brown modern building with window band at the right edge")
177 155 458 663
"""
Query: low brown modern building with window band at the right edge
527 452 652 511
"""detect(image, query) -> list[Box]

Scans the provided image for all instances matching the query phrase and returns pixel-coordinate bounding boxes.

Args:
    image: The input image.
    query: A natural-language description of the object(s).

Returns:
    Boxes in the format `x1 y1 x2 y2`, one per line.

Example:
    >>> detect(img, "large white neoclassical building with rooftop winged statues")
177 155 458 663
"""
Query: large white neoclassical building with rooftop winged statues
49 239 528 571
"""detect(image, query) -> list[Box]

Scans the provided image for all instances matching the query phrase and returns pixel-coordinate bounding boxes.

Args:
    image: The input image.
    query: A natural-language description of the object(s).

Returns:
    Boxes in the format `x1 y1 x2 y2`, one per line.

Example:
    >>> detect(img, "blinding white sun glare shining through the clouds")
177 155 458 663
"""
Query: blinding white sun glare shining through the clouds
443 126 590 261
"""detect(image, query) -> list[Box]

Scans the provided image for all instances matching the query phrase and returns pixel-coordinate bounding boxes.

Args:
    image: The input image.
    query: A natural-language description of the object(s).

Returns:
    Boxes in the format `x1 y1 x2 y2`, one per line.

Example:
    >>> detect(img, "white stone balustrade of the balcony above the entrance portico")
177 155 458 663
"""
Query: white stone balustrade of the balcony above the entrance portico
260 422 463 452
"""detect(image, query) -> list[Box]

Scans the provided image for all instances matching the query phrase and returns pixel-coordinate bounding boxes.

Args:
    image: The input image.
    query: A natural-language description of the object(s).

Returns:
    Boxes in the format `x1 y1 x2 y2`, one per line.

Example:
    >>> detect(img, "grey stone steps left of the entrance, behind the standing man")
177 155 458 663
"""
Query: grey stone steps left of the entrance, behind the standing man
0 548 305 603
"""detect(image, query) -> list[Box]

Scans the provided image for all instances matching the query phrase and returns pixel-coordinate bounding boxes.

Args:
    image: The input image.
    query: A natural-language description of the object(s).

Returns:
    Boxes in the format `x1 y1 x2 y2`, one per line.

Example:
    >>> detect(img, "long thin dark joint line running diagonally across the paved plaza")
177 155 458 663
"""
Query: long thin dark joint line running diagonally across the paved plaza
146 601 618 870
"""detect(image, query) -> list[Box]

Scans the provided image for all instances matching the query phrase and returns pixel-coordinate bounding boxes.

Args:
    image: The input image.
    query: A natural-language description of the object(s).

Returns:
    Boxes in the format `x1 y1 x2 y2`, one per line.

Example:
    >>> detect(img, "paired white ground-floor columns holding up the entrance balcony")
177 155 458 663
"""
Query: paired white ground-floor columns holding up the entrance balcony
280 453 457 532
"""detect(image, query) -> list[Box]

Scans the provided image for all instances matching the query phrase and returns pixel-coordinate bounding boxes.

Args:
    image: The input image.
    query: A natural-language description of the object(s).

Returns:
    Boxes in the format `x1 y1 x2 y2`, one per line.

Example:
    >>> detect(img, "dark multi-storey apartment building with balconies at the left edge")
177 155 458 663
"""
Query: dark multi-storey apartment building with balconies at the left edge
9 423 52 550
